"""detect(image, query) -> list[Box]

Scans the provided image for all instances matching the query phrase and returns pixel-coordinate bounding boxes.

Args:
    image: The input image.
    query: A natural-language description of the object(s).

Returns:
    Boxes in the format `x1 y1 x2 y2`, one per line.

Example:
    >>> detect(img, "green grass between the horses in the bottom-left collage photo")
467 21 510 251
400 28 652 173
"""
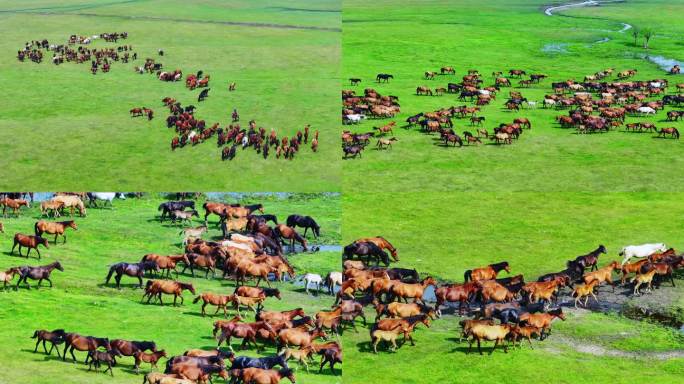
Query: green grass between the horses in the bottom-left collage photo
0 195 341 383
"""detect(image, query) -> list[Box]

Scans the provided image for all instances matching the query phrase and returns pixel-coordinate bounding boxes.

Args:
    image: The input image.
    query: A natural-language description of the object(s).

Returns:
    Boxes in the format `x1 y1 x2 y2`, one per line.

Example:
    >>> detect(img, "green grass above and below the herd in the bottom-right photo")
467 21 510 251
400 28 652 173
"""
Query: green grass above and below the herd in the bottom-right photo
342 192 684 383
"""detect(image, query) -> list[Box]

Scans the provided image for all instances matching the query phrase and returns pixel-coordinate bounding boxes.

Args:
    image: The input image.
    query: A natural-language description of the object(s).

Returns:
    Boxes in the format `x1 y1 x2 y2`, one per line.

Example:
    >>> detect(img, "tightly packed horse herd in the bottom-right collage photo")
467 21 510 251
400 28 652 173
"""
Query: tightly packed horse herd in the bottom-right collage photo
337 237 684 354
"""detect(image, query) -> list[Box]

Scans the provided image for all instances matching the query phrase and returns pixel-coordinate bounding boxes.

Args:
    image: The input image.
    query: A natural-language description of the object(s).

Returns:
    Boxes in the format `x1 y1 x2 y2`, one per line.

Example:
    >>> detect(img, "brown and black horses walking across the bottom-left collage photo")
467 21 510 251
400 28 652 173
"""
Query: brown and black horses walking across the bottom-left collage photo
0 193 342 384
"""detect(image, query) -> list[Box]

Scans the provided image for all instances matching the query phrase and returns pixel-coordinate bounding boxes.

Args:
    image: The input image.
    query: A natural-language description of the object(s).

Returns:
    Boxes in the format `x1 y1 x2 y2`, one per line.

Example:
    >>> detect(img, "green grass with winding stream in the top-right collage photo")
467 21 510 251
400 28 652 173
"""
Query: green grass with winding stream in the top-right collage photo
342 0 684 192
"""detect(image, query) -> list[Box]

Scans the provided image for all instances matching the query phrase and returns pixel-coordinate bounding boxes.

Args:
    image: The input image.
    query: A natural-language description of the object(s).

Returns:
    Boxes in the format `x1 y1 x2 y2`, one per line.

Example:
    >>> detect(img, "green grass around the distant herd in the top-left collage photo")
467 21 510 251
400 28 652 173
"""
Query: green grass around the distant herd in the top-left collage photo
0 0 341 192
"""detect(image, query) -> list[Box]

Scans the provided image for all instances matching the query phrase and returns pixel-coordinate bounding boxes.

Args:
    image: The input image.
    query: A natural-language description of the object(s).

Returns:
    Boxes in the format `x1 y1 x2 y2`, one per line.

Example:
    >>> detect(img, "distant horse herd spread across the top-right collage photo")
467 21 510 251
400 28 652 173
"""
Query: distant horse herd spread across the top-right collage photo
342 66 684 158
